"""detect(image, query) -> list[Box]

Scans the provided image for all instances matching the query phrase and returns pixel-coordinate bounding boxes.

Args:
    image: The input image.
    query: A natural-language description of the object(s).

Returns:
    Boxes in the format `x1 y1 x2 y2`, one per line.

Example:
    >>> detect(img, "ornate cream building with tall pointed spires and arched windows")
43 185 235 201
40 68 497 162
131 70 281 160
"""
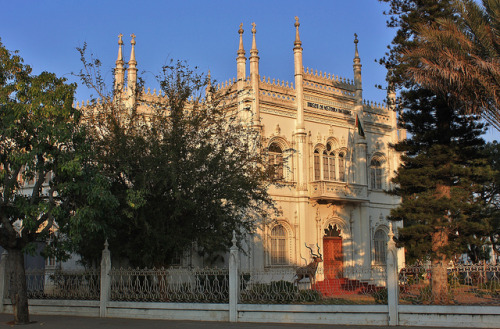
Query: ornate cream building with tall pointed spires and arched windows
83 18 405 279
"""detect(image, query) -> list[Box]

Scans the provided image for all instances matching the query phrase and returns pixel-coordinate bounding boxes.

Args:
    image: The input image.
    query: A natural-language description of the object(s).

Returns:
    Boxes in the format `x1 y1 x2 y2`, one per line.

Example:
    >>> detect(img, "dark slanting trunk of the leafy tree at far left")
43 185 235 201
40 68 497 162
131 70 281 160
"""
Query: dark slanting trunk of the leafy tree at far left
7 249 30 324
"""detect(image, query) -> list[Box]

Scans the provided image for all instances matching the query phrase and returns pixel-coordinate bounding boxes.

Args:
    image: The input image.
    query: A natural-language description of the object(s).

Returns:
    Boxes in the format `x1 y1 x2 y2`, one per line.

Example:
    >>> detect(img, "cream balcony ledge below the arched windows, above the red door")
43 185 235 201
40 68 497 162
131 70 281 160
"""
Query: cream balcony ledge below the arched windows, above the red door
309 181 368 202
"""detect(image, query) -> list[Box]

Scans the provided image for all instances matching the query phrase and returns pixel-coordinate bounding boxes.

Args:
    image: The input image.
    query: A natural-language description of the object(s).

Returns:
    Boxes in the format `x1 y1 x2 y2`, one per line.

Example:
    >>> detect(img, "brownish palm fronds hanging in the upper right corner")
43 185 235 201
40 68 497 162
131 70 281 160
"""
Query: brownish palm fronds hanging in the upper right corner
402 0 500 130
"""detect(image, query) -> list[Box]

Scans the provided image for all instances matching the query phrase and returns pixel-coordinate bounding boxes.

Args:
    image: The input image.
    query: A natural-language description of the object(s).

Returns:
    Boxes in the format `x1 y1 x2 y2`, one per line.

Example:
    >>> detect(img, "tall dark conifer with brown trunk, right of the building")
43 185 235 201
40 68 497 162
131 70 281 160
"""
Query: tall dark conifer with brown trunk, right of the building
381 0 492 303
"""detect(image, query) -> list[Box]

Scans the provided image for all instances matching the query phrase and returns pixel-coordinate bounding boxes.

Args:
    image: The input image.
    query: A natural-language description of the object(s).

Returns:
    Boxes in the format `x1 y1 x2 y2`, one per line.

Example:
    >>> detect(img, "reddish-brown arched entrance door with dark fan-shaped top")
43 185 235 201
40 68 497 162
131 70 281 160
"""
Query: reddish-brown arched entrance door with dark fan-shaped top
323 224 344 279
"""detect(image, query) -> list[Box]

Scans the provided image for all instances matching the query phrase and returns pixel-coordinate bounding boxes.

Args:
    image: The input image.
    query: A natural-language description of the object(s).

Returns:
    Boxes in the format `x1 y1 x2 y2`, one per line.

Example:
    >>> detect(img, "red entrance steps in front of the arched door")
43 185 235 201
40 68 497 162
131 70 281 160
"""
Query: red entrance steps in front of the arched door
313 278 383 297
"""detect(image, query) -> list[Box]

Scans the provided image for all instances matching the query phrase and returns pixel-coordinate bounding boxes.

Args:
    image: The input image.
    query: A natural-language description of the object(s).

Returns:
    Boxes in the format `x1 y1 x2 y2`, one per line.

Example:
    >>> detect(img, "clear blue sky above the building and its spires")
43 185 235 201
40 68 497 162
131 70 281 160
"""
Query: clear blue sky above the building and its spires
0 0 500 140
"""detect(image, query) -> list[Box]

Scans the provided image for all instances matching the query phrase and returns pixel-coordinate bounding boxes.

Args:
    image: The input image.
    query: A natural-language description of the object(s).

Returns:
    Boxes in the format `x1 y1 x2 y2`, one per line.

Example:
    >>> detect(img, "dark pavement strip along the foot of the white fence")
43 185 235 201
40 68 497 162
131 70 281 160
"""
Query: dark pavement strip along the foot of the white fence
0 313 460 329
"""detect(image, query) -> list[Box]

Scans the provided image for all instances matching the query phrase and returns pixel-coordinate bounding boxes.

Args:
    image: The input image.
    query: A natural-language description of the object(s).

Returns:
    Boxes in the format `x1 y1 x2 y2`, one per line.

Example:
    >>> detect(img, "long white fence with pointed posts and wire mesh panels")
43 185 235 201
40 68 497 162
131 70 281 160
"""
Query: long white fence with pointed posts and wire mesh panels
0 233 500 328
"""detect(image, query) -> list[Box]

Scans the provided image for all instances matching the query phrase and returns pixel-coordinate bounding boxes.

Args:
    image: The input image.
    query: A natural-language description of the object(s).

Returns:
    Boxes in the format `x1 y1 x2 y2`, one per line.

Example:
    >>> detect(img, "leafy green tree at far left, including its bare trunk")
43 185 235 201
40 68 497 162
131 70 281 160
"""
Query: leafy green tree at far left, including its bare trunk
0 39 109 324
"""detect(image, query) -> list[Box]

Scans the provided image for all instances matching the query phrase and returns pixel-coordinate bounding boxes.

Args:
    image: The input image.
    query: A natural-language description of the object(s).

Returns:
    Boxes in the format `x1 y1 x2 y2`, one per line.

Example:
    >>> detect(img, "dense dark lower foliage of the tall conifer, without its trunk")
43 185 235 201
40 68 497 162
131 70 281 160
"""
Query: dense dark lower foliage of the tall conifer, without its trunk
390 90 493 260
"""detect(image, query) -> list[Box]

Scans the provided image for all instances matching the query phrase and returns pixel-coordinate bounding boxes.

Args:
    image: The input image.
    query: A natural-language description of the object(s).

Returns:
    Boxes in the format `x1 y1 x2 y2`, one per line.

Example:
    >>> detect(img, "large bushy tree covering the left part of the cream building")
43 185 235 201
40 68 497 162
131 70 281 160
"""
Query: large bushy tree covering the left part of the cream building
72 55 274 266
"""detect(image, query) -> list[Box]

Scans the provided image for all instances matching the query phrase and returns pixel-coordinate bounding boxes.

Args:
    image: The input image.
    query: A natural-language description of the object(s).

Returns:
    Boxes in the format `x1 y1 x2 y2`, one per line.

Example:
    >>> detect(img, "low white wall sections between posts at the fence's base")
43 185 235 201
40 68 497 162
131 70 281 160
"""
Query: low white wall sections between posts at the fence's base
4 299 500 328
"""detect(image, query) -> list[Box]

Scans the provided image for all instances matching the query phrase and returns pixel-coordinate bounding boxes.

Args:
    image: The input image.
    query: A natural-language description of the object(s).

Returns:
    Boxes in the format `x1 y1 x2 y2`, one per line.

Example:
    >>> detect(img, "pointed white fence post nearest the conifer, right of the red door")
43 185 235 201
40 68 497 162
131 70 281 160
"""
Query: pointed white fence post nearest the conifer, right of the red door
386 223 399 326
